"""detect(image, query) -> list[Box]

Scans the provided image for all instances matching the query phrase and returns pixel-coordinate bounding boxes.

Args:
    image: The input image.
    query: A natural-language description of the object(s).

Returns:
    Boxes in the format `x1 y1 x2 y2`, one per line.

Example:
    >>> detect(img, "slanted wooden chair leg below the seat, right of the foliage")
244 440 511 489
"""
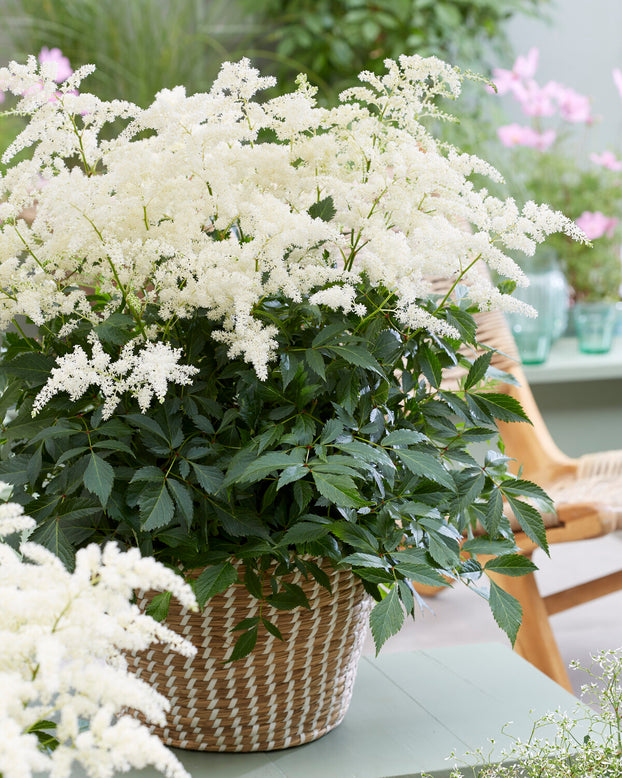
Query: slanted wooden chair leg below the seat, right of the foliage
495 573 573 692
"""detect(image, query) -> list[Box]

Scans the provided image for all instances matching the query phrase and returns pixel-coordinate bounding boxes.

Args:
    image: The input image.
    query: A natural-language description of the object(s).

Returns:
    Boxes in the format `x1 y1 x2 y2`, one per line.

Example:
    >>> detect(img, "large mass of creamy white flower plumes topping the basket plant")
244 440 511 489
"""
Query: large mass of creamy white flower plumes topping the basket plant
0 56 580 392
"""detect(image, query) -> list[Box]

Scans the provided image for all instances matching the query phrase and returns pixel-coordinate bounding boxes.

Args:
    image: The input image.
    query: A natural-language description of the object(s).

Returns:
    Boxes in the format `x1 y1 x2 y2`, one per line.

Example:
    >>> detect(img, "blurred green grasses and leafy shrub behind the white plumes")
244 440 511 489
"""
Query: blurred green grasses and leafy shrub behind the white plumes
0 0 551 150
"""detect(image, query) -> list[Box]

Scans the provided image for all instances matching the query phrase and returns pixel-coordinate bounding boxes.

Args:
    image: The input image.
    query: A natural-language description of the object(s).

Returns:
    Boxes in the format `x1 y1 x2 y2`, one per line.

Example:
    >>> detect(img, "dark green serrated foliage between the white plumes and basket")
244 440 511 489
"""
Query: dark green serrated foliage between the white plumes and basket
0 282 546 658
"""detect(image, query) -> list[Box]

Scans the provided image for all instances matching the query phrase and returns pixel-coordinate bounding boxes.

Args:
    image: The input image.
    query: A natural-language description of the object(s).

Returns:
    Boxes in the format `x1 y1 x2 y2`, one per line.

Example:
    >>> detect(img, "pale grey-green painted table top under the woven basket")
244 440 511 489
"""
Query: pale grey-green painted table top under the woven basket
135 644 582 778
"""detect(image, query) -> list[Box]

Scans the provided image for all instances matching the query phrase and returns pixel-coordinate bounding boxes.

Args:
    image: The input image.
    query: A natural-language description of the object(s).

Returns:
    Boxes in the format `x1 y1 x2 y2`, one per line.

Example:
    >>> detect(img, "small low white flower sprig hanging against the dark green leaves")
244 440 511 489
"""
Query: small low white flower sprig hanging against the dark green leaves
32 333 198 419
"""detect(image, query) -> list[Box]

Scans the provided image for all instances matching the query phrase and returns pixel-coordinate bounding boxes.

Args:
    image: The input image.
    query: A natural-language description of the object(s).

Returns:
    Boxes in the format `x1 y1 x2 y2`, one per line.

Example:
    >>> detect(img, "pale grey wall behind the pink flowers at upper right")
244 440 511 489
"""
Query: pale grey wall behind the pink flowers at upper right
508 0 622 152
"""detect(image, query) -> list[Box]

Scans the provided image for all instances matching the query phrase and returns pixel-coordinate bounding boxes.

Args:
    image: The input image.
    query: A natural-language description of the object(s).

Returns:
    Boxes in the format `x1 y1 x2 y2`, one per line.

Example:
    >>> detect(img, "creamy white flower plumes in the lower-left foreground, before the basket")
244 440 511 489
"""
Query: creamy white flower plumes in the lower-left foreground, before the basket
0 503 196 778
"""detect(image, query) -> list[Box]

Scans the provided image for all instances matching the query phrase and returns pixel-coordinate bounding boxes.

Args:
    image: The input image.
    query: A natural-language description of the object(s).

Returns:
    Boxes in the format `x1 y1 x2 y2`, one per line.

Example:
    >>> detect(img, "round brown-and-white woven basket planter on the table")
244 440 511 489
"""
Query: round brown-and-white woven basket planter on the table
129 569 371 751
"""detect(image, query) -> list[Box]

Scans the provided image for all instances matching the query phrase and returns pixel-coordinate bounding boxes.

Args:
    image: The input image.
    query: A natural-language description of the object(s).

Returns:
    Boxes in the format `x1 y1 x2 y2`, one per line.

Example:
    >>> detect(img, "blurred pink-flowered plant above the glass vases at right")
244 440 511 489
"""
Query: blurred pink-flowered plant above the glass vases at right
491 48 622 300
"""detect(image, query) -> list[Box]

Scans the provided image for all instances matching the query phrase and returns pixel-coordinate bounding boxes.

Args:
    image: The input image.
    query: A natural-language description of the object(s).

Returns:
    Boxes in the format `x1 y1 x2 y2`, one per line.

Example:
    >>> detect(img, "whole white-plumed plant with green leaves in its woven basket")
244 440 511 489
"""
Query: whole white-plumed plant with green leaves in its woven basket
0 57 581 750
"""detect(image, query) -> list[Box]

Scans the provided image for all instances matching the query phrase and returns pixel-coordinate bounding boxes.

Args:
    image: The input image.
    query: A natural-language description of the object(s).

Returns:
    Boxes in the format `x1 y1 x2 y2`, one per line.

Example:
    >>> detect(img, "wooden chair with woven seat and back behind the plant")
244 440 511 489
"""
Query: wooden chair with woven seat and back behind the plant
458 312 622 691
